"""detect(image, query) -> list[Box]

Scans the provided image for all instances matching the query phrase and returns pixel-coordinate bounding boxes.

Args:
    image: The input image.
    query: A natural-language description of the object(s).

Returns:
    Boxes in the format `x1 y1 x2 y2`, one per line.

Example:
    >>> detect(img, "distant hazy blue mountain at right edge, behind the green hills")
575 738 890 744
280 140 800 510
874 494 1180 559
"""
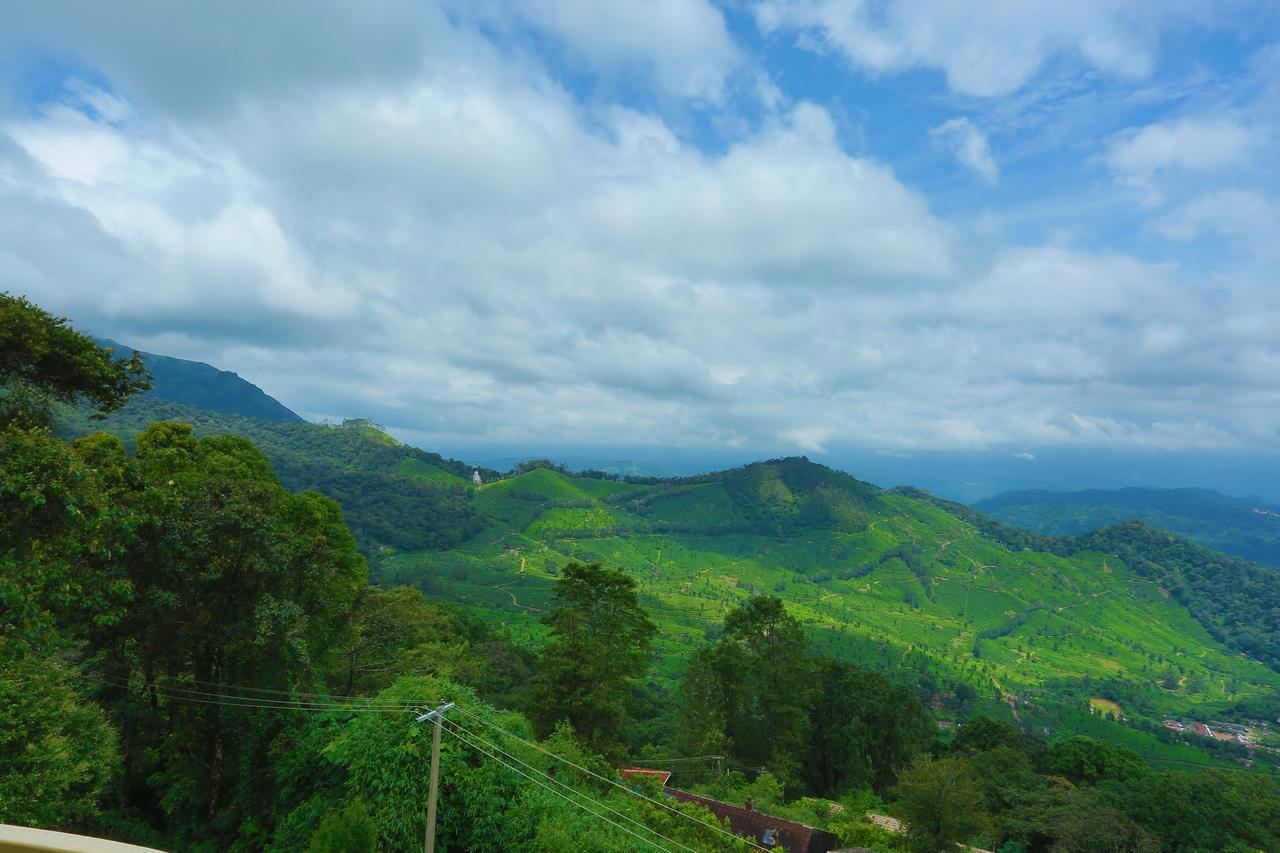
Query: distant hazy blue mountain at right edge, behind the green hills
973 488 1280 567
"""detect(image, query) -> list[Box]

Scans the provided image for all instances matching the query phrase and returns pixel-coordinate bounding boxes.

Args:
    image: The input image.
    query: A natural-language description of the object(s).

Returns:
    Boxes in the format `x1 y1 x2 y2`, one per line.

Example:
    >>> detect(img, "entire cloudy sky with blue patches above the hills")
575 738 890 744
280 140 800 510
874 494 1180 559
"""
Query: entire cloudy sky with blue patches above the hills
0 0 1280 471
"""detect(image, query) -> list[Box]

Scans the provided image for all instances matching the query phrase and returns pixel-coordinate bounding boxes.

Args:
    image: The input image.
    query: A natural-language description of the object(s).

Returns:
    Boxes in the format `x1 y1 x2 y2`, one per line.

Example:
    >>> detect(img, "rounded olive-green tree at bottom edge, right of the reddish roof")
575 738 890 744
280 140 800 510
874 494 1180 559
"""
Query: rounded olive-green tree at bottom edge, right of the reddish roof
893 756 986 853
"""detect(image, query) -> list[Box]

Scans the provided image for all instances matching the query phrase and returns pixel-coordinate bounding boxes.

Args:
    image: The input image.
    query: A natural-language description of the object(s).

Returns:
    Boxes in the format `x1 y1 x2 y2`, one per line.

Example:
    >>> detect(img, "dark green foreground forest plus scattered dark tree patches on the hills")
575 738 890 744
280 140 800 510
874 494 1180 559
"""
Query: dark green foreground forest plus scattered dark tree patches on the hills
0 289 1280 853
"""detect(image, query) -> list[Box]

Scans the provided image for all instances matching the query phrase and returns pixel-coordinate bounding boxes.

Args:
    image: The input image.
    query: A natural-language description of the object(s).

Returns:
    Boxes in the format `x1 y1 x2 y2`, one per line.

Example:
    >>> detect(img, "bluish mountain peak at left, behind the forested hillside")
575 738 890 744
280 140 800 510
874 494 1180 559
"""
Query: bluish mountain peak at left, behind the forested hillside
99 338 302 424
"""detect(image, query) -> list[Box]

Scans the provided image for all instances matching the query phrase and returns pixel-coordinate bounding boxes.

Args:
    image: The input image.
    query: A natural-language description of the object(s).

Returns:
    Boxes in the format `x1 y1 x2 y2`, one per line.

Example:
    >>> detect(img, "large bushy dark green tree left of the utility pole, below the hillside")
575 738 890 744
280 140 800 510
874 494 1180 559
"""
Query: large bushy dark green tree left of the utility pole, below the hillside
80 424 367 843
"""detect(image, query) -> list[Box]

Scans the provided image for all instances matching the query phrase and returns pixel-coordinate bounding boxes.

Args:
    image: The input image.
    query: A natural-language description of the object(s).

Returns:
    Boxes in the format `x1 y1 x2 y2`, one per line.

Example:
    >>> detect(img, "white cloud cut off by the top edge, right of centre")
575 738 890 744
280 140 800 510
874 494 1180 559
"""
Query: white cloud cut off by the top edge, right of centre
753 0 1204 96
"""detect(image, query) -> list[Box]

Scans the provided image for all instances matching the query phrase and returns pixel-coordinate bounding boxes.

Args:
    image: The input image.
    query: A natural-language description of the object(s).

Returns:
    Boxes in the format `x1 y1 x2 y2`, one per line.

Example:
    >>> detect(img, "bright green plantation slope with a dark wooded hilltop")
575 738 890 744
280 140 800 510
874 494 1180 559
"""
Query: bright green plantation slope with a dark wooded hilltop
380 461 1280 762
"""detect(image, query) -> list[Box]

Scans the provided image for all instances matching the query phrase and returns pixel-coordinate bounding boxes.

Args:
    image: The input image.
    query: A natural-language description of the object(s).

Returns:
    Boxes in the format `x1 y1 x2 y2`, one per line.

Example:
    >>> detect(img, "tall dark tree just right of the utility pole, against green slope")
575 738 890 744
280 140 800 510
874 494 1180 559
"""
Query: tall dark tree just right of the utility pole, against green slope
530 562 657 752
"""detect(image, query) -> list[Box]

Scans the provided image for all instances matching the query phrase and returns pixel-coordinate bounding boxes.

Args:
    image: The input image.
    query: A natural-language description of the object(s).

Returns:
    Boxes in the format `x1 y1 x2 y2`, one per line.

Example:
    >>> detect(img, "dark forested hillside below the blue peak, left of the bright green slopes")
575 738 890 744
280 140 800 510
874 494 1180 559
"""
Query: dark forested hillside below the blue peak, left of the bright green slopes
59 397 498 551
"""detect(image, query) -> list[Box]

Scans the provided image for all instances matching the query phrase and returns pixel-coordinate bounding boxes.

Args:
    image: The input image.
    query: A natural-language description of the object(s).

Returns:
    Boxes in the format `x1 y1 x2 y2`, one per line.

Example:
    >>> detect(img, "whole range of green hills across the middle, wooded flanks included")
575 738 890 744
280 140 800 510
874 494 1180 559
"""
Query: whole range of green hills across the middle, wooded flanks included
63 353 1280 763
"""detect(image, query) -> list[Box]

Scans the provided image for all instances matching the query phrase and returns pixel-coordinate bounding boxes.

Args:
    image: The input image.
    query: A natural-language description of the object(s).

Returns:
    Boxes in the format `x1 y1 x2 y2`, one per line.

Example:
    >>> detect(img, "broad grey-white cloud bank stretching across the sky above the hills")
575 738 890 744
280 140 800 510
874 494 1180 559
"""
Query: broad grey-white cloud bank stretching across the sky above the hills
0 4 1280 452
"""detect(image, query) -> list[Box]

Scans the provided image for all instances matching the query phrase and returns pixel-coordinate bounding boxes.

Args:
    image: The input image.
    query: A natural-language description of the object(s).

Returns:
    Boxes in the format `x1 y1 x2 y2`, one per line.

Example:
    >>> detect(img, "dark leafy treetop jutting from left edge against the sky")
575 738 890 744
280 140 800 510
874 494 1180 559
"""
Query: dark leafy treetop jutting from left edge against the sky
0 293 151 425
